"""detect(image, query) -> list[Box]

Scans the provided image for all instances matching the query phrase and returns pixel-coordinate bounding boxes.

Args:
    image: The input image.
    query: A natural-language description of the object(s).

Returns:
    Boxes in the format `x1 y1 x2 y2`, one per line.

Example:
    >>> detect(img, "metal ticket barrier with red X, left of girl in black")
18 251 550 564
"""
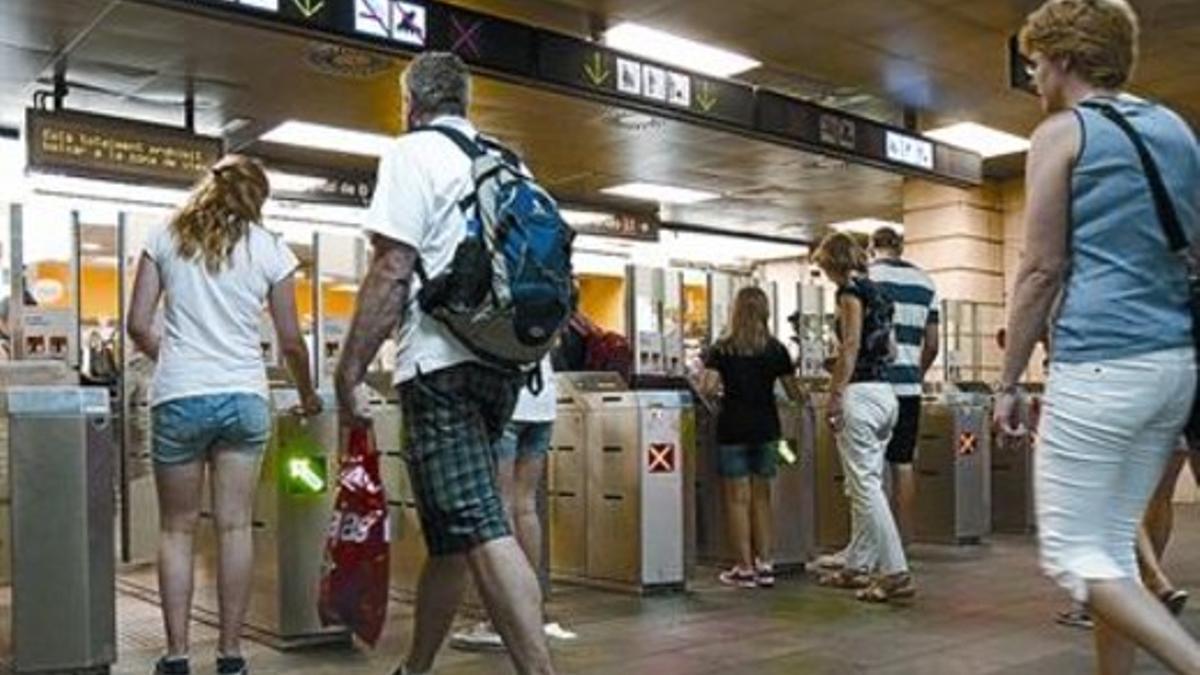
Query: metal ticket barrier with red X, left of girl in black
548 374 694 592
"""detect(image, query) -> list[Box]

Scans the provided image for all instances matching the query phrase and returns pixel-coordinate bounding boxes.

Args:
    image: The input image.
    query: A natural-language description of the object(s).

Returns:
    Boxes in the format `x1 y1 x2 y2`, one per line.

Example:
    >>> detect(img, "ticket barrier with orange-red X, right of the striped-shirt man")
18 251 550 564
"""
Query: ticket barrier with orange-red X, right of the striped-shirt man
913 384 991 544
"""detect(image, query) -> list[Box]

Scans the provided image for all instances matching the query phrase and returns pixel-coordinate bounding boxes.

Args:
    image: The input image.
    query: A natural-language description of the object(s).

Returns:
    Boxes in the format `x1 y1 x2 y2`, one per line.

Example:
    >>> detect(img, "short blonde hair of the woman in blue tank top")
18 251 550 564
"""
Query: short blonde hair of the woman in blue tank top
1020 0 1140 89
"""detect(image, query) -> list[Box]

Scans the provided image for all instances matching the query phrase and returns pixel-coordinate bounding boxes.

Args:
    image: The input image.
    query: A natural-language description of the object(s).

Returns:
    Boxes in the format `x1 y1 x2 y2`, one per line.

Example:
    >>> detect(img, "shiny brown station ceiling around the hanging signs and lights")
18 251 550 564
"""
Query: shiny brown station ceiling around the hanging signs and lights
0 0 1200 238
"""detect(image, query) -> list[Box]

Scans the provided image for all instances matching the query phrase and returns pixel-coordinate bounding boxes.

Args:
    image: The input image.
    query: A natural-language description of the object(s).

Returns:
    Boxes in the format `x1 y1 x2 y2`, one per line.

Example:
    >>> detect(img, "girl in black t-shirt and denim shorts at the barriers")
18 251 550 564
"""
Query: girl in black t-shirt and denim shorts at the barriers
703 288 799 589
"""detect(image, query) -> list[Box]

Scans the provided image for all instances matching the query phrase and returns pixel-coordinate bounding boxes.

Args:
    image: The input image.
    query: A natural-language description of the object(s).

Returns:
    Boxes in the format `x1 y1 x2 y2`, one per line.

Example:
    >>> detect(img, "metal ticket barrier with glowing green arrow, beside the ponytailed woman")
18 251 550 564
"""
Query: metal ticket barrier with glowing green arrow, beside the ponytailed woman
194 388 350 649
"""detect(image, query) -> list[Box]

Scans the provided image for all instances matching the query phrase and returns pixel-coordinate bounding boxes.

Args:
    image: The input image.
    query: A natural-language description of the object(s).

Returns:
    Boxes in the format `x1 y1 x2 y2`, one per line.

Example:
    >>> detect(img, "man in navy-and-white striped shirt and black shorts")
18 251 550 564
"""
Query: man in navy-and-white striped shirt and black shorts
870 227 938 542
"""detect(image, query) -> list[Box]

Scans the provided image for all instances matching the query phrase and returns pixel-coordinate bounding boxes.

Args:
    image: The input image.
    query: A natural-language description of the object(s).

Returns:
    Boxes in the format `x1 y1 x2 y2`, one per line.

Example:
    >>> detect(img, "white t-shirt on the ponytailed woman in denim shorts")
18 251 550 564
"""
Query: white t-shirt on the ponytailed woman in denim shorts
145 226 299 405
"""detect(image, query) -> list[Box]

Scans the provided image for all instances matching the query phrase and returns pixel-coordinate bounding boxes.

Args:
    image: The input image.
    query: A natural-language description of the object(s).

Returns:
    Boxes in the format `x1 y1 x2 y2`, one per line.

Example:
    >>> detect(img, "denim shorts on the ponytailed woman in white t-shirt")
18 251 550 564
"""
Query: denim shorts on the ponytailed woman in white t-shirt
151 393 271 465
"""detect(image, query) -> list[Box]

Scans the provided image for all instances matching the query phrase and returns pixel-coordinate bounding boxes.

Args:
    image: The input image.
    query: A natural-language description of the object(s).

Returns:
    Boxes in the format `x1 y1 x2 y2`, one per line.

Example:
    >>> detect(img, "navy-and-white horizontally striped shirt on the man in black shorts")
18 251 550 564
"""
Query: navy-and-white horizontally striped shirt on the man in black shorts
870 258 938 396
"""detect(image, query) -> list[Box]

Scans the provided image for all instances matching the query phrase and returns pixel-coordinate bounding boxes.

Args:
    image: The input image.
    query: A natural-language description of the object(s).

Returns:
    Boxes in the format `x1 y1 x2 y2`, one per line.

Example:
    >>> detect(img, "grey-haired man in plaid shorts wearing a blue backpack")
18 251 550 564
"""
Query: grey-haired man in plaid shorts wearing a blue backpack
336 53 571 675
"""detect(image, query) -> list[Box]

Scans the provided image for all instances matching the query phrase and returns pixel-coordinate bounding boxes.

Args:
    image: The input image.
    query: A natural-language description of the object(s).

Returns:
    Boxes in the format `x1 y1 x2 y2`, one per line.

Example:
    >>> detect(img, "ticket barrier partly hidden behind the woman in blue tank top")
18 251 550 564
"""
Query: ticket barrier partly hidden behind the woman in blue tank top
991 398 1040 534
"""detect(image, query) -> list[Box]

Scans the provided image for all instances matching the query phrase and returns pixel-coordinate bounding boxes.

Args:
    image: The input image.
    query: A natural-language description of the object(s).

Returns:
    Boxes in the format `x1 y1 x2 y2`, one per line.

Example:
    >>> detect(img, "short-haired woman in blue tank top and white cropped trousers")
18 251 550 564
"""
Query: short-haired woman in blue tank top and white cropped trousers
995 0 1200 673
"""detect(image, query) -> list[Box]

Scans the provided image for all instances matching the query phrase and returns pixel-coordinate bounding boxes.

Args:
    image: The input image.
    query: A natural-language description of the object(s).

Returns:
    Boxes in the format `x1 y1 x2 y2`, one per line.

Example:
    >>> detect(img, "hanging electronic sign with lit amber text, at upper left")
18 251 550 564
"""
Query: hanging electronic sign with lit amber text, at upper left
25 109 223 186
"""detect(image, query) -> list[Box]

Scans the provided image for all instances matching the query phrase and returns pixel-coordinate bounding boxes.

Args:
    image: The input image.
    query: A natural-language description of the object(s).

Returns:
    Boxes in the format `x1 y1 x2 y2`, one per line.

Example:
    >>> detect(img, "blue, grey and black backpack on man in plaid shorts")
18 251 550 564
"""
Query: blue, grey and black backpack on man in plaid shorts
414 126 575 372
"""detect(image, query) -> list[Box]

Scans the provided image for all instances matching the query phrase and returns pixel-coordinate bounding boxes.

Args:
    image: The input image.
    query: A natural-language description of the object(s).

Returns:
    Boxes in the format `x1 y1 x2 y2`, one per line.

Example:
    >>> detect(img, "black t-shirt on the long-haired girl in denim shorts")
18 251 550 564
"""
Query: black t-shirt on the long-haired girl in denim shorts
704 338 793 446
